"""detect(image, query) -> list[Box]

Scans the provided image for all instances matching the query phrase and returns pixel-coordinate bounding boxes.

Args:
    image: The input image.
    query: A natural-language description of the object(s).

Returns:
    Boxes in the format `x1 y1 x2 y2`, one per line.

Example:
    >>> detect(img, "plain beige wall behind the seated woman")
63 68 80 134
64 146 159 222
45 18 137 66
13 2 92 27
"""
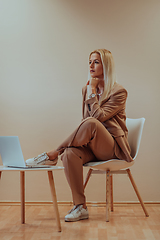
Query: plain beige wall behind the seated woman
0 0 160 202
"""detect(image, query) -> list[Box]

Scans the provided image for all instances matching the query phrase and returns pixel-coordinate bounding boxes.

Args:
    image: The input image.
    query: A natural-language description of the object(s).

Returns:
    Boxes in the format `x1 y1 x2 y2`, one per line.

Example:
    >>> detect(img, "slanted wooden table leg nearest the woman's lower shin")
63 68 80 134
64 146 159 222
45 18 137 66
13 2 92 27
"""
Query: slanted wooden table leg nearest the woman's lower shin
48 171 61 232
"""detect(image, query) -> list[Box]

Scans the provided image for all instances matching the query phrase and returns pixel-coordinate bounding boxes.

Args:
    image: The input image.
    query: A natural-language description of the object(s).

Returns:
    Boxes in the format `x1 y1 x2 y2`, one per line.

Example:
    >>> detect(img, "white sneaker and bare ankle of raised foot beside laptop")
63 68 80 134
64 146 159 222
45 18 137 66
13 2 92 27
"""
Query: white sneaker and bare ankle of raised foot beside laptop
26 152 58 166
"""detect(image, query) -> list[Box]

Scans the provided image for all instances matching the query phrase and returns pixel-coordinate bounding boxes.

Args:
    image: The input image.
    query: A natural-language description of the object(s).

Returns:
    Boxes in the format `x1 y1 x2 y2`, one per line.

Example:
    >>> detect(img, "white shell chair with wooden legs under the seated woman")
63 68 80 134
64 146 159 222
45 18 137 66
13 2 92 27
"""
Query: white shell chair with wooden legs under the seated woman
84 118 149 222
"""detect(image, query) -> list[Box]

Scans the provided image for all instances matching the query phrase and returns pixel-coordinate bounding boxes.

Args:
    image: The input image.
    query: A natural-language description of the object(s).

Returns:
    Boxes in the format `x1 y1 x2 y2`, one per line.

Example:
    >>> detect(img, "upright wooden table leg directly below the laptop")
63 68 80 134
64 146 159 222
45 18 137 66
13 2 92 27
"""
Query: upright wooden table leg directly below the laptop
20 171 25 224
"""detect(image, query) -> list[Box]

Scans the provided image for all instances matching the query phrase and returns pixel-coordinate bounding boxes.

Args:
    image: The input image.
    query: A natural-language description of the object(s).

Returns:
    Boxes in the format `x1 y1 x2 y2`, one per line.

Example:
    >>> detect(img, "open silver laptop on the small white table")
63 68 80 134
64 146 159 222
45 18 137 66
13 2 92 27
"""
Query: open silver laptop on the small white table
0 136 51 168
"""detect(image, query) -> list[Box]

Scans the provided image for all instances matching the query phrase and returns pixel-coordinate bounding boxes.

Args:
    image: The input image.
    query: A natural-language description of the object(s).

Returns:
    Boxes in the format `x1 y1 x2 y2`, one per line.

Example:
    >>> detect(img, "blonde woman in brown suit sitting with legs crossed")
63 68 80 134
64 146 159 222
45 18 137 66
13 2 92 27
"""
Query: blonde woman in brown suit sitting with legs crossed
26 49 132 221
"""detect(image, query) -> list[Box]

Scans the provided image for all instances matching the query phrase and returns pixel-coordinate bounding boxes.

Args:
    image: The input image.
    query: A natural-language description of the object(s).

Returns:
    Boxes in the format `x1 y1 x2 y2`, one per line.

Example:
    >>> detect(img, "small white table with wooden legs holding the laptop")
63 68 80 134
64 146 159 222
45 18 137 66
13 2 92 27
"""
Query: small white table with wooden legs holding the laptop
0 166 64 232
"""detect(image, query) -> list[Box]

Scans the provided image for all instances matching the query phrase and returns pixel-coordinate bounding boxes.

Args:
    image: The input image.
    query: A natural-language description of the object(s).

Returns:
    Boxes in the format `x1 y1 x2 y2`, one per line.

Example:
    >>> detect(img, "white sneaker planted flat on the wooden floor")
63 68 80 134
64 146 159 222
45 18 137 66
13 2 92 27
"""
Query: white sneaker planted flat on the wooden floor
65 205 89 222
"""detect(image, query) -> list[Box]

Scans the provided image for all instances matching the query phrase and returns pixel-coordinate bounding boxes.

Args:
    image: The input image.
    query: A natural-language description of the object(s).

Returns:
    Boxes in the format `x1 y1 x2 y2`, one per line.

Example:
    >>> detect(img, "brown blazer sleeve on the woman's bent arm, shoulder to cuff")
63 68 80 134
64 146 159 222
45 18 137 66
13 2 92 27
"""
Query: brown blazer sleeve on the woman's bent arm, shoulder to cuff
85 88 127 122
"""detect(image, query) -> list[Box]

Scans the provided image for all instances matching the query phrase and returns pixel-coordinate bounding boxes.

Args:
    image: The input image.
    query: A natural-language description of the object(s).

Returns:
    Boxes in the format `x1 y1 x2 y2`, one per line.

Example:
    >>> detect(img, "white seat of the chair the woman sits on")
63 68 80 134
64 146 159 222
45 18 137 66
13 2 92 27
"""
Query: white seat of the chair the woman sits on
84 159 134 171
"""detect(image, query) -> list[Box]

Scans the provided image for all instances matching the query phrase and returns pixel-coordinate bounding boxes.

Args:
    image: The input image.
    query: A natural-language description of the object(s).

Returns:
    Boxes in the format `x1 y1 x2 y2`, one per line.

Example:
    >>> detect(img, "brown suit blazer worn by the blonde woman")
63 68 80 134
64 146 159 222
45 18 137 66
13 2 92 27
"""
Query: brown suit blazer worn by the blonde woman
82 83 133 162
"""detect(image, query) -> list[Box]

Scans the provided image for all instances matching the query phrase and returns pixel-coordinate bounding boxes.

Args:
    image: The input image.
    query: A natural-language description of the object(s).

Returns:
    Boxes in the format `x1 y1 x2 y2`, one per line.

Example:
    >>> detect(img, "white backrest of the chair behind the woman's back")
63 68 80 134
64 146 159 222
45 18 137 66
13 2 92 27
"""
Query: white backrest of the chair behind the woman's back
126 118 145 159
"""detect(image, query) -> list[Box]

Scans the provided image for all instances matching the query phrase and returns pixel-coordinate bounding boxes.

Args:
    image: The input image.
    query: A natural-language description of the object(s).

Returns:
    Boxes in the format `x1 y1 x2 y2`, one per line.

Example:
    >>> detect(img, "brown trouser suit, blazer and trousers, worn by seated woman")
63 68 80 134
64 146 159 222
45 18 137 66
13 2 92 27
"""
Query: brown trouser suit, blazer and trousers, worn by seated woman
57 83 132 205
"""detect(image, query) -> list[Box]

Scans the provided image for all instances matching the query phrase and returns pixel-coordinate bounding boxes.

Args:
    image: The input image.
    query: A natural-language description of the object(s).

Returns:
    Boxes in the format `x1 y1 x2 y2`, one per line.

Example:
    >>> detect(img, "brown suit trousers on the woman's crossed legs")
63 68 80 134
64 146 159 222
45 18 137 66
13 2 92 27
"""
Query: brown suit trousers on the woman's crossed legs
57 117 115 205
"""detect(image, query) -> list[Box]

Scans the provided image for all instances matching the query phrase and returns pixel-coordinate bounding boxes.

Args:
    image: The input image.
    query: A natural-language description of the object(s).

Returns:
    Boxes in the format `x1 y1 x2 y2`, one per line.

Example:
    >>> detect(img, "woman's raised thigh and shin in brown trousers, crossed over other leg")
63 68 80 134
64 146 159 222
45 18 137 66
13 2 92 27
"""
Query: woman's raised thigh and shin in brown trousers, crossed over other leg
56 117 115 160
